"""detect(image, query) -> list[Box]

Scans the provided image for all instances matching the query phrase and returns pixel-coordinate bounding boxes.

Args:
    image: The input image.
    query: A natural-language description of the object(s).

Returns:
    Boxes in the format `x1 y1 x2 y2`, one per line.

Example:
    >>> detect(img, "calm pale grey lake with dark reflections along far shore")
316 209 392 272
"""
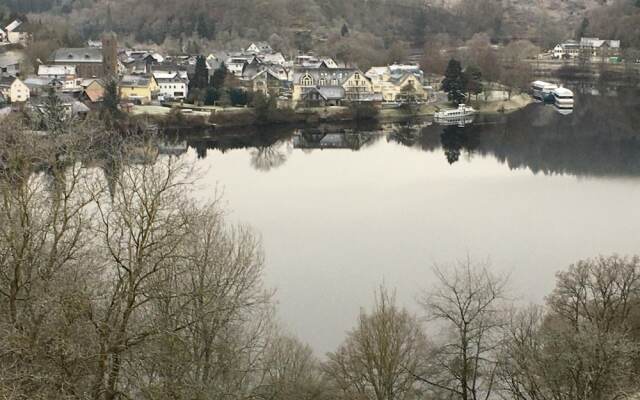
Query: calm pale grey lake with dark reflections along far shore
166 85 640 354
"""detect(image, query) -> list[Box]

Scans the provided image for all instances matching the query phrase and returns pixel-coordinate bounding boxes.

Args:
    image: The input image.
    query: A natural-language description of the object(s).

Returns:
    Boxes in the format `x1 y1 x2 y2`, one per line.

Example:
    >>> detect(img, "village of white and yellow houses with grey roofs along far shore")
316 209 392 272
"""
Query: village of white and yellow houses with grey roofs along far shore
0 20 636 126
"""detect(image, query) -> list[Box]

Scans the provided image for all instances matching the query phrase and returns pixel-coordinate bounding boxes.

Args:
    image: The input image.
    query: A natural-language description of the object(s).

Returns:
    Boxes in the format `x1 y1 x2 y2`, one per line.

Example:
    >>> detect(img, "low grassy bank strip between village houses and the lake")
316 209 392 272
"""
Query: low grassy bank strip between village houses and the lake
131 94 533 128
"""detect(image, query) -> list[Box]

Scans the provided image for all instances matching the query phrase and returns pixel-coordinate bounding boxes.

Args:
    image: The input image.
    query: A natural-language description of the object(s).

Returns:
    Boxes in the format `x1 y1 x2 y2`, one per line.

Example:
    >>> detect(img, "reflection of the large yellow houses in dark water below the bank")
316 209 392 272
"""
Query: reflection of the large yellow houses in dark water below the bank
293 129 381 150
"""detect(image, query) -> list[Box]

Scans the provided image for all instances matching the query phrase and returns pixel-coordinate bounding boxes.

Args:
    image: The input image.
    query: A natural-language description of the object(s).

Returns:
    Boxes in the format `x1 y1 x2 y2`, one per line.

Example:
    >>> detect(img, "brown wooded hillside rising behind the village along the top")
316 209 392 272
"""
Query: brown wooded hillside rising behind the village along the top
0 0 640 63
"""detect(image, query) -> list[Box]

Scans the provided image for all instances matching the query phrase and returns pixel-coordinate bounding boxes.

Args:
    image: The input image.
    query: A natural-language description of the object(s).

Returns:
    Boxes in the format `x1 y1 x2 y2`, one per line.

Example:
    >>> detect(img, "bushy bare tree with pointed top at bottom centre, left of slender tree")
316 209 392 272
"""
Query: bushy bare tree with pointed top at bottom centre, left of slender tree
324 288 427 400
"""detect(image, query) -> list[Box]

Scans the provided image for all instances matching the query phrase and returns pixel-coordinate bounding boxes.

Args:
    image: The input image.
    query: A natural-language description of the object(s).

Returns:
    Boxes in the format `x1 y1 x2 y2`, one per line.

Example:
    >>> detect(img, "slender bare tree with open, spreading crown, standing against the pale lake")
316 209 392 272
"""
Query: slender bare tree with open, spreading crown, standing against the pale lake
419 259 507 400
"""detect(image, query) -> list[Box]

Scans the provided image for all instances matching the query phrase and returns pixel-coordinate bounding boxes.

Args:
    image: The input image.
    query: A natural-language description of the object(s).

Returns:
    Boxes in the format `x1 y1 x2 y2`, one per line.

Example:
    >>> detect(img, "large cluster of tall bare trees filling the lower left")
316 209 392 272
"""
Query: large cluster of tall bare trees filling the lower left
0 121 284 400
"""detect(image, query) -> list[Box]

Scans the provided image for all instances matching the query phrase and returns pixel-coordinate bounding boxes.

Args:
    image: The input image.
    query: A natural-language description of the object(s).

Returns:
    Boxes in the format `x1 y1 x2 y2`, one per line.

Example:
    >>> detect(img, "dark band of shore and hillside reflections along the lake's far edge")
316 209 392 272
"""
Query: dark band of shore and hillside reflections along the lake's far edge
169 87 640 176
